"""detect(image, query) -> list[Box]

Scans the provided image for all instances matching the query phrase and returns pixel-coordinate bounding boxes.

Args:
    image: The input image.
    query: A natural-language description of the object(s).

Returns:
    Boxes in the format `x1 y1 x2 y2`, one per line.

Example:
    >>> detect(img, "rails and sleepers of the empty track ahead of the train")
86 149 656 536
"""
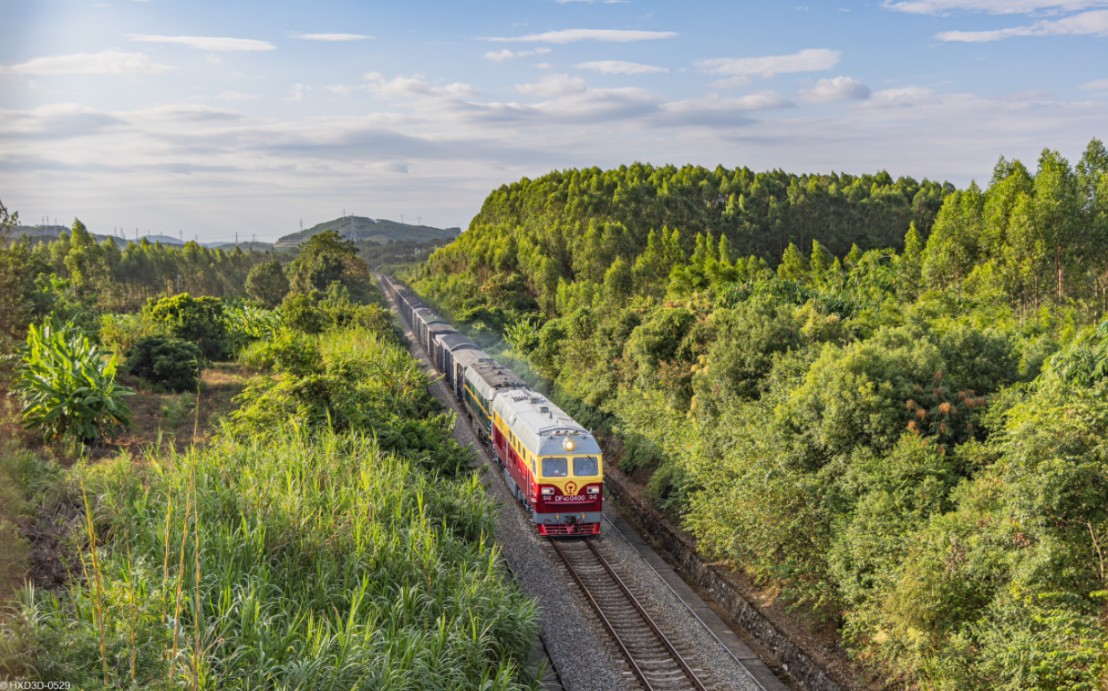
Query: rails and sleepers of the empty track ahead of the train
550 539 710 691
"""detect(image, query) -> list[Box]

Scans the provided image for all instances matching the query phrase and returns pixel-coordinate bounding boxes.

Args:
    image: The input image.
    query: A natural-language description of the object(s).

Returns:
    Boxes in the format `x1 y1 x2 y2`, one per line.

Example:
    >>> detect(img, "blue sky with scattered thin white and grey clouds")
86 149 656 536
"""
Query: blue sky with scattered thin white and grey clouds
0 0 1108 241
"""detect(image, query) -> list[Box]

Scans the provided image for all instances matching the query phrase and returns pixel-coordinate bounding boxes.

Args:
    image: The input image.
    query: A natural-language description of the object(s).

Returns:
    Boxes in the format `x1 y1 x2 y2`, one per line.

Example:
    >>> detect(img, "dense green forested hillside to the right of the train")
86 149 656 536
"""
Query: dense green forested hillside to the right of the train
409 140 1108 689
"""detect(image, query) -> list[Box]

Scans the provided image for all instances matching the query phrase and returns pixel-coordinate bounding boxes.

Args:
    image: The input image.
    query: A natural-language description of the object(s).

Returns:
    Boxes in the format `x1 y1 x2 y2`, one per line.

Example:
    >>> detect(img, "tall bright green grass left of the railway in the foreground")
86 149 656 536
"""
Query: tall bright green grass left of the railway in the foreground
0 321 537 689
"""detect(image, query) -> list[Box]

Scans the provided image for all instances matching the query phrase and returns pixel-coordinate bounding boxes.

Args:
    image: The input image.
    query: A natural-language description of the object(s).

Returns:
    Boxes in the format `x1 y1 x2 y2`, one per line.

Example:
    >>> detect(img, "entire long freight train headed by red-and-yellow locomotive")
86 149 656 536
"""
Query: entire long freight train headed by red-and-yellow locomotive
379 276 604 537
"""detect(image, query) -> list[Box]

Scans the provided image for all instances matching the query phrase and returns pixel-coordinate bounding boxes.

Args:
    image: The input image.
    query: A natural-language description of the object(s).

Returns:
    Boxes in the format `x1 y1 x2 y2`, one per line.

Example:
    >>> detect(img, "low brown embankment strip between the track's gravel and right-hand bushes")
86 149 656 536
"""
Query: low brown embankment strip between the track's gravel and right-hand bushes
604 464 846 691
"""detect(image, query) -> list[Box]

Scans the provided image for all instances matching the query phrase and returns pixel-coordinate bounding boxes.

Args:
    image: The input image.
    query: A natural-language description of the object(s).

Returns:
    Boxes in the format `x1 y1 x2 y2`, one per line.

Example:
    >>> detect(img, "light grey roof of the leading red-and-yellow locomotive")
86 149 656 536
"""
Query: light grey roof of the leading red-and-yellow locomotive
492 390 602 456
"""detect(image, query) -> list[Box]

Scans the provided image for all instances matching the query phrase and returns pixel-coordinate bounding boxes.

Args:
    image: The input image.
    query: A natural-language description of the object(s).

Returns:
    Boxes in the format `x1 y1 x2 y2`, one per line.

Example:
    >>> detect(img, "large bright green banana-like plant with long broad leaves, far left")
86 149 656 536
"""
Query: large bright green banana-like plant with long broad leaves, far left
14 321 132 443
